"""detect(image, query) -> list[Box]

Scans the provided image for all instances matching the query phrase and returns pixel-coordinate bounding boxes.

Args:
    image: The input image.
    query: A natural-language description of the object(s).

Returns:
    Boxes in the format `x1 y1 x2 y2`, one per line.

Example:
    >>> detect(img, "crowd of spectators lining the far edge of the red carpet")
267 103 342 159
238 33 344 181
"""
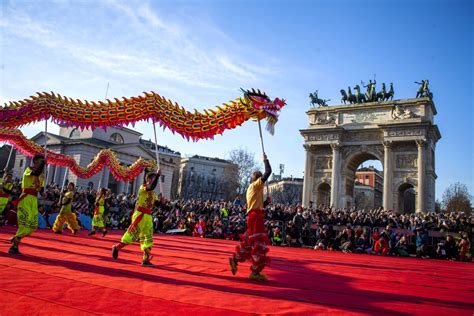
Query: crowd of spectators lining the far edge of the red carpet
1 182 474 261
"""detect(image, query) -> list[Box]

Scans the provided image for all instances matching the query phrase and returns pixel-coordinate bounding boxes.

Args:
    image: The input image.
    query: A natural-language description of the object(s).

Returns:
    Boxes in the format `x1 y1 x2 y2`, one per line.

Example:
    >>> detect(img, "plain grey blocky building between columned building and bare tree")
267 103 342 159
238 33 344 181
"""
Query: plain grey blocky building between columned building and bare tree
178 155 238 201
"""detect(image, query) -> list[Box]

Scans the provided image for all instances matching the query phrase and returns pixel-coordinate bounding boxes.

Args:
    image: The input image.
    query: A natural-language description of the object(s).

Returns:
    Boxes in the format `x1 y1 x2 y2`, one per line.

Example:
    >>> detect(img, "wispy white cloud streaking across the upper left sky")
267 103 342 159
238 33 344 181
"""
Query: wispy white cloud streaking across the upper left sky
0 0 271 89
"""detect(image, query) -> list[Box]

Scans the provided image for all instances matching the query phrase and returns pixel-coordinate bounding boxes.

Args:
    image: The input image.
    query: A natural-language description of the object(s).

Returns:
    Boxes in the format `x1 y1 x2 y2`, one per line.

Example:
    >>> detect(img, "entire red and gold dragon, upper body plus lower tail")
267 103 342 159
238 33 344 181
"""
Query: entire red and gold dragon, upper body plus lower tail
0 89 285 181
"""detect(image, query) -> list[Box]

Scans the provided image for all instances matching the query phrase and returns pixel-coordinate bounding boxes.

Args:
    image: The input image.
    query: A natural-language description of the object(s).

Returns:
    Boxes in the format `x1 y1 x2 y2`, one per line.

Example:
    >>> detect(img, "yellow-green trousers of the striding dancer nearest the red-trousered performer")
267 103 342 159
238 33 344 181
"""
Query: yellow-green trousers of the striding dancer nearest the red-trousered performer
121 211 153 251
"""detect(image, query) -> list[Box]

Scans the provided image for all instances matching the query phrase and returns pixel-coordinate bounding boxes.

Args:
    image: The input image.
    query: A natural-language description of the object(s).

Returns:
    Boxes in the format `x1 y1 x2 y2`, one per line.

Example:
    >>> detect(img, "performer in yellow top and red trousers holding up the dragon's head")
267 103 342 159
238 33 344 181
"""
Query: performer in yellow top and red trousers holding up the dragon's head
229 153 272 281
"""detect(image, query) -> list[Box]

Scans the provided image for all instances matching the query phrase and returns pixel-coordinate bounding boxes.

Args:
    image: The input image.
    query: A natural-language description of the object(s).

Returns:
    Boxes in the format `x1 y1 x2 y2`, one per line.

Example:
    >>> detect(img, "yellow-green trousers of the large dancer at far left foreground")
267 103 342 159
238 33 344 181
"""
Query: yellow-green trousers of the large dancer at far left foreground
15 194 38 238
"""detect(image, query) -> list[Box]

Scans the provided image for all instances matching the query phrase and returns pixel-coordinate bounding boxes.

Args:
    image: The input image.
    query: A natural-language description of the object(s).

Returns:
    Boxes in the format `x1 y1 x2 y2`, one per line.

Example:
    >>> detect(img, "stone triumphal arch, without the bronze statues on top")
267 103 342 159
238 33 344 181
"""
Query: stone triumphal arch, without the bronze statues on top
300 94 441 211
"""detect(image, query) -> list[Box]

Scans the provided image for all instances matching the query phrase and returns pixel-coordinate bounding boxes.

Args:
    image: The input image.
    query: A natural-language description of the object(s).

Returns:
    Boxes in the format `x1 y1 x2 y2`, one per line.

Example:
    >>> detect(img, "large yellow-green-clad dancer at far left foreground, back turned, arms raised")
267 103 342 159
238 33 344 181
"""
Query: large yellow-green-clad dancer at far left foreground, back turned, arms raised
8 155 46 255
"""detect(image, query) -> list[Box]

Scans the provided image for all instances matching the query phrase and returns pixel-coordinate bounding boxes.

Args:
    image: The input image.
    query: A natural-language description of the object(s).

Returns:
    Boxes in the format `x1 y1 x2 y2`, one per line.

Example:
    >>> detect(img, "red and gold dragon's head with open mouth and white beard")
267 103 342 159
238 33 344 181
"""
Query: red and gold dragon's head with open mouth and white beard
240 88 286 135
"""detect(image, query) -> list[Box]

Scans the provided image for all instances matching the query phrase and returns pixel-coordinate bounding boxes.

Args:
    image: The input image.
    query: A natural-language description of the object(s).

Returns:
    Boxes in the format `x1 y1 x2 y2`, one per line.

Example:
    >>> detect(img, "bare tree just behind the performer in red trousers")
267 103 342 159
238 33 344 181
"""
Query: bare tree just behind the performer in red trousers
227 147 261 197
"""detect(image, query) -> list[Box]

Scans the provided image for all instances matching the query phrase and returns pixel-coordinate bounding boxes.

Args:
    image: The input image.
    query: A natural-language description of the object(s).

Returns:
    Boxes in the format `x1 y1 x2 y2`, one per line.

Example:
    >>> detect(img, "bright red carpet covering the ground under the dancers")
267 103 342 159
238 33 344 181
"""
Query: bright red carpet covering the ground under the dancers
0 227 474 315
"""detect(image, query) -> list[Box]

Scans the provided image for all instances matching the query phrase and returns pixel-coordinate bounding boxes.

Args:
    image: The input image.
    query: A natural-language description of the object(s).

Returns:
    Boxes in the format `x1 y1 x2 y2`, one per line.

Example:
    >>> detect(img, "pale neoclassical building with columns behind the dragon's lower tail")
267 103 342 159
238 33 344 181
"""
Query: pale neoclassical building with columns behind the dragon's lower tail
13 126 181 198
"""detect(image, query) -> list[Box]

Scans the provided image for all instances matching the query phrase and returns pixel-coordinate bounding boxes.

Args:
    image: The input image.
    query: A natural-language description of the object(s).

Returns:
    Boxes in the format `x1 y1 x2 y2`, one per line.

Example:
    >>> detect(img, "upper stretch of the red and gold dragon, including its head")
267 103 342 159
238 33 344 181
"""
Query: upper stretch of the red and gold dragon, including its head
0 90 285 141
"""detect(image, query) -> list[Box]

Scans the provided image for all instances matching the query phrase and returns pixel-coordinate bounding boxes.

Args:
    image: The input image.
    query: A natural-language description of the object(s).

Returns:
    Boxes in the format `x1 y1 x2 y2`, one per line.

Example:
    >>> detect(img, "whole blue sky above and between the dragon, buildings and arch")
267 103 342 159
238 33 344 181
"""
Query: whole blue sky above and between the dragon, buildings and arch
0 0 474 198
